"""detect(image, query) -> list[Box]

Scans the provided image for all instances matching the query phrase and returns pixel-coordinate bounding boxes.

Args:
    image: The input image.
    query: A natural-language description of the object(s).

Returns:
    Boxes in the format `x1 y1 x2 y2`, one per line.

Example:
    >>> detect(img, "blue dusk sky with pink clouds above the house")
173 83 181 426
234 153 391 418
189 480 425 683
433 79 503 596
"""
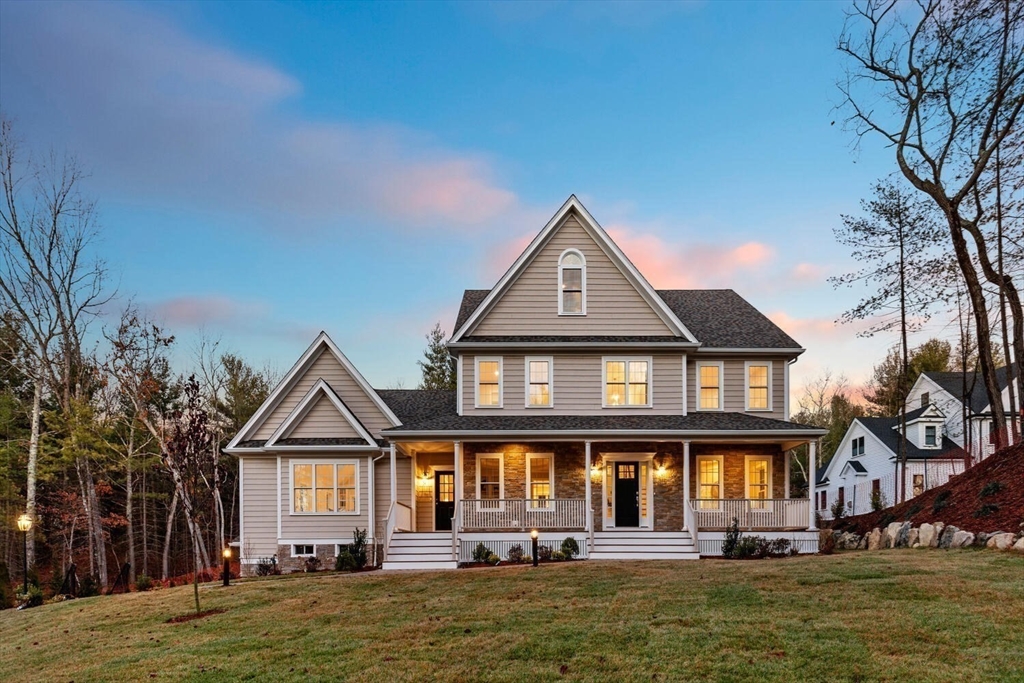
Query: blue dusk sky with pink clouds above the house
0 2 934 401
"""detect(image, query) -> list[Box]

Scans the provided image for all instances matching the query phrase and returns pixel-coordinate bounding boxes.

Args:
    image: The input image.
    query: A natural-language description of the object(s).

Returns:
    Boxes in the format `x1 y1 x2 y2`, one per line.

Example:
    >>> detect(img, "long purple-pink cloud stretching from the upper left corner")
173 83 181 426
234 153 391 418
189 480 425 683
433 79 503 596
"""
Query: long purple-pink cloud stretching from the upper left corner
0 3 518 229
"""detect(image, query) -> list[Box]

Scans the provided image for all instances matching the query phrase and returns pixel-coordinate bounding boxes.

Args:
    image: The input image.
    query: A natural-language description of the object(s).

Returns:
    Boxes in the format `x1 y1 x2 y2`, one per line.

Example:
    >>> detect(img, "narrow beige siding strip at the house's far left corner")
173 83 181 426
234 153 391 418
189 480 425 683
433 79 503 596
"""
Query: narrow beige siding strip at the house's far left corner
239 456 278 560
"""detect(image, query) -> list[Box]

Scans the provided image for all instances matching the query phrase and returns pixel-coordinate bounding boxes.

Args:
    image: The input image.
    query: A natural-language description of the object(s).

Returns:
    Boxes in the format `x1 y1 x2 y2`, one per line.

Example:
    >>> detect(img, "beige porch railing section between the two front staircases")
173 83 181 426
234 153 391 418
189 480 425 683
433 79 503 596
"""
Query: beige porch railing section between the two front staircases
456 498 587 531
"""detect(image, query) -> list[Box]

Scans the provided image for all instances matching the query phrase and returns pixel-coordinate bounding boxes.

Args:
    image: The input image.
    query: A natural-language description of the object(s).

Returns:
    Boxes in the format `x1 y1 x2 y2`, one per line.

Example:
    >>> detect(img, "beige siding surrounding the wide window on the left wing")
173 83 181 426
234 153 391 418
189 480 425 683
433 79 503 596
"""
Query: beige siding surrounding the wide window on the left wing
281 453 370 543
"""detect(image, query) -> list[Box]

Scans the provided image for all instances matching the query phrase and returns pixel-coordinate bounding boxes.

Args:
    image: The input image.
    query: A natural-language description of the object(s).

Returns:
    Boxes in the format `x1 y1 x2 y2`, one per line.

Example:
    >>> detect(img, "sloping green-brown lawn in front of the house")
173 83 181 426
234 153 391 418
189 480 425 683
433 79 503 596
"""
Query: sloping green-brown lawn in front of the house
0 550 1024 682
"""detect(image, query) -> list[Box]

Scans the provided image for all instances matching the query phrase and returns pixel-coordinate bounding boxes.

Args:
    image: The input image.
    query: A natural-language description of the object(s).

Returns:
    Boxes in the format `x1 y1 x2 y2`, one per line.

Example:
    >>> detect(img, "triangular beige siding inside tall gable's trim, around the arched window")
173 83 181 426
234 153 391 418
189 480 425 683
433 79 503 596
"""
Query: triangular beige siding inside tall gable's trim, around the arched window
470 213 673 336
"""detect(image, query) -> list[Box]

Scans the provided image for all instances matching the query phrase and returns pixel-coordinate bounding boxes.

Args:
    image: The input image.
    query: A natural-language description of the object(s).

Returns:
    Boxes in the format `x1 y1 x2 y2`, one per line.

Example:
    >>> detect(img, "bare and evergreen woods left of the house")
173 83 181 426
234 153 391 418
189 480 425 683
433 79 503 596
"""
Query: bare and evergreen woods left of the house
0 121 275 587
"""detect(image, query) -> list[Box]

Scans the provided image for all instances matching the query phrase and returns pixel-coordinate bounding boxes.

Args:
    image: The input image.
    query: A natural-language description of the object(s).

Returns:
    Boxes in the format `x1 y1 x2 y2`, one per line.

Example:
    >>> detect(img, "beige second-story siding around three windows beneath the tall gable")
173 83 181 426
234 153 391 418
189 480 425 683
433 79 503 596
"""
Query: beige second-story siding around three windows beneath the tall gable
463 353 683 415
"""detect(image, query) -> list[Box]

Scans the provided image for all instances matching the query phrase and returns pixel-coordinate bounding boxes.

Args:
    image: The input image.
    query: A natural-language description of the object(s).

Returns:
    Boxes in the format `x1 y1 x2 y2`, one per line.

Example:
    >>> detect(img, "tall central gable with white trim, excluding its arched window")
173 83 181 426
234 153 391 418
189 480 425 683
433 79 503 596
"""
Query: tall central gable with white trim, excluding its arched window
451 196 697 344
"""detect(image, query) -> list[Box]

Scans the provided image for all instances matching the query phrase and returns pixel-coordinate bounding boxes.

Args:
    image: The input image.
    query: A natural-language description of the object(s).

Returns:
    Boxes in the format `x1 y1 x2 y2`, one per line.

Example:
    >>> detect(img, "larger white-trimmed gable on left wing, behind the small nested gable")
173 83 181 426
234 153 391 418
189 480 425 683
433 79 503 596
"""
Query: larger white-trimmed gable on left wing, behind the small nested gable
226 332 401 452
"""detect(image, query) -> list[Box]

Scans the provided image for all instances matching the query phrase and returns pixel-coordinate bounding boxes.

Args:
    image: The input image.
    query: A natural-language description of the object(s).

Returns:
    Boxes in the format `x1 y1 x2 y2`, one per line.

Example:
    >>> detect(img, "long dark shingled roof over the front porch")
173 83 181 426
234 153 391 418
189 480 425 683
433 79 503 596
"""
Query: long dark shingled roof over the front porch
381 412 825 440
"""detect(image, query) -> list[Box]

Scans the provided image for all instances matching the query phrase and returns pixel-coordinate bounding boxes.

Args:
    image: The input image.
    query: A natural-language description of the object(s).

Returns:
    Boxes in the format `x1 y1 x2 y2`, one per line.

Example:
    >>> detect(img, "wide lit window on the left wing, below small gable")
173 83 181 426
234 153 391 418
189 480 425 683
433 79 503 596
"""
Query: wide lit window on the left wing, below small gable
292 461 359 514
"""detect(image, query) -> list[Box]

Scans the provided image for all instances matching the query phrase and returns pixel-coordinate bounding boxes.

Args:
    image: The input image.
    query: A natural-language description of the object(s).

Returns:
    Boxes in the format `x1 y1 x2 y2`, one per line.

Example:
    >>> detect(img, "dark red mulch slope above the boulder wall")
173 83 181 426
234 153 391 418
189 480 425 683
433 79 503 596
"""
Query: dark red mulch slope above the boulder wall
833 443 1024 533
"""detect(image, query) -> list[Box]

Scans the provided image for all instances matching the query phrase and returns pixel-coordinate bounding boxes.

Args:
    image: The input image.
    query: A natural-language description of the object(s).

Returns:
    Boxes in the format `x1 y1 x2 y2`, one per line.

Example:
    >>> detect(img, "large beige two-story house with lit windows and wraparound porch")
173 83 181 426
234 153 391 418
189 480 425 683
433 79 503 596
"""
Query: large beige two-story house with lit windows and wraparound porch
227 197 823 568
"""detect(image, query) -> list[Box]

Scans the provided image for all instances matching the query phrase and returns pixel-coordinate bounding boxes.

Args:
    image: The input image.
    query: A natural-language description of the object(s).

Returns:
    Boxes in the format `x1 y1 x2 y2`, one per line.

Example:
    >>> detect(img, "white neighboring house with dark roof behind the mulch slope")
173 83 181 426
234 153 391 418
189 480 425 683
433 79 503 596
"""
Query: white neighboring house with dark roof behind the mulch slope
815 368 1013 519
